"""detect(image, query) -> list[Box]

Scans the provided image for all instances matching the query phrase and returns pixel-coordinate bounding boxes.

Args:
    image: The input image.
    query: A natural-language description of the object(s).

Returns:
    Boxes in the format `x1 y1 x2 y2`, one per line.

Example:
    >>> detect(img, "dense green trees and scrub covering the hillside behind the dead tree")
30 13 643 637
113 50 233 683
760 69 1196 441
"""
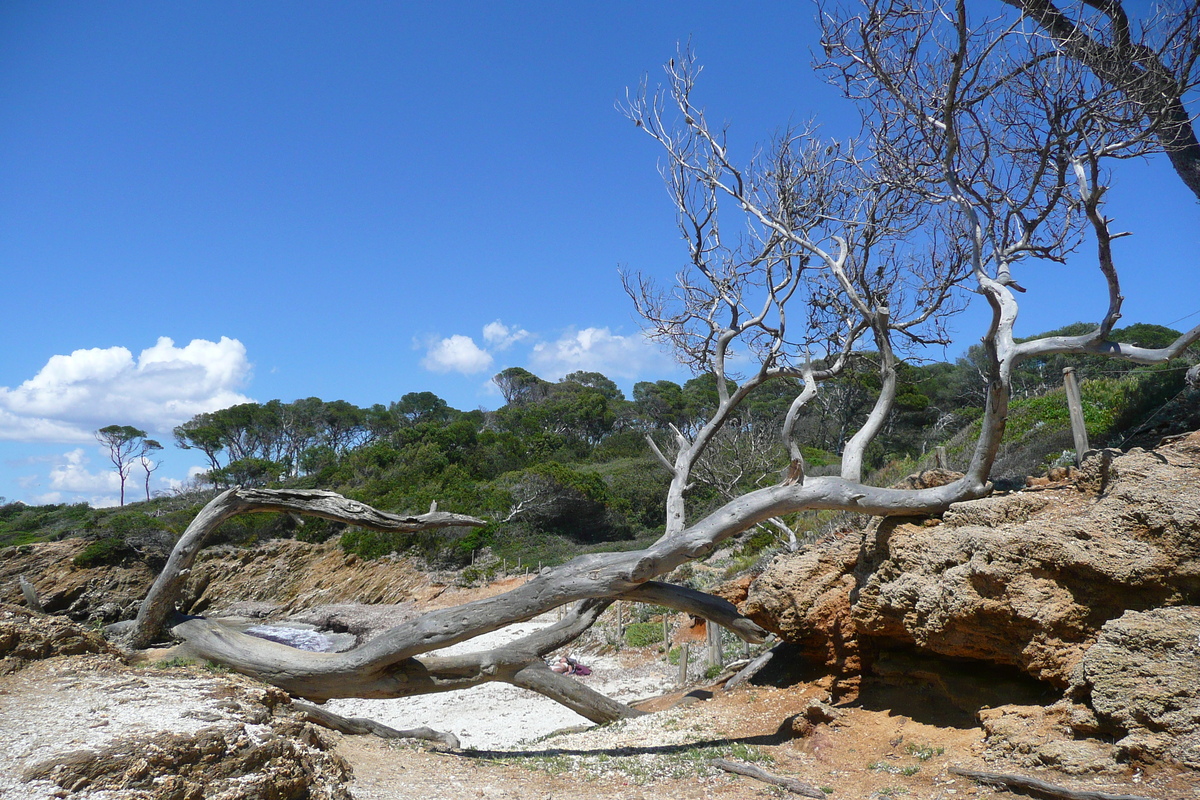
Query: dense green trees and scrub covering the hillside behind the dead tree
0 324 1196 571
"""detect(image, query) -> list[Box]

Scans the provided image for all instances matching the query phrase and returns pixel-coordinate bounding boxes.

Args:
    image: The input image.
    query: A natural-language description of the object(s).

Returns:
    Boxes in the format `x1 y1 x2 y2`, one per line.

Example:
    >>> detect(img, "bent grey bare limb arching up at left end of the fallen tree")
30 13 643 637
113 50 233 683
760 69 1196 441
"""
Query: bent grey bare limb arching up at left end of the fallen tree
127 487 486 648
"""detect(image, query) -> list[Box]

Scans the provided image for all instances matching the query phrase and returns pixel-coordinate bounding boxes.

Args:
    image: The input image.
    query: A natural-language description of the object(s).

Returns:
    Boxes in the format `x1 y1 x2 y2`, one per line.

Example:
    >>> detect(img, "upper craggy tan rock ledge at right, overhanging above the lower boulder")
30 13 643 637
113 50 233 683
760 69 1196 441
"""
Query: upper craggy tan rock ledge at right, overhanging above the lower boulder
743 433 1200 688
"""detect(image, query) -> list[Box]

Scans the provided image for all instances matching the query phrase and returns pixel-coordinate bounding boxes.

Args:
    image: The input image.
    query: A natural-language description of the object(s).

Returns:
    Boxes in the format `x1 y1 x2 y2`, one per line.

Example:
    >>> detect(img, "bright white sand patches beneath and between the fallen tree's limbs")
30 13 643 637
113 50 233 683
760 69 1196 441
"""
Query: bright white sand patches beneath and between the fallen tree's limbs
325 616 676 750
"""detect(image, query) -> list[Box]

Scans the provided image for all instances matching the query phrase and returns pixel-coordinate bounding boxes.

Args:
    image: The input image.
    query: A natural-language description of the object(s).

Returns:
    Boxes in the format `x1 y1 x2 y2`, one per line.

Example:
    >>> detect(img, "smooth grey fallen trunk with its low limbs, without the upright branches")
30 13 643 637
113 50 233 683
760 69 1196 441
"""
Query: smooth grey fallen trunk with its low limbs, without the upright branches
140 477 988 722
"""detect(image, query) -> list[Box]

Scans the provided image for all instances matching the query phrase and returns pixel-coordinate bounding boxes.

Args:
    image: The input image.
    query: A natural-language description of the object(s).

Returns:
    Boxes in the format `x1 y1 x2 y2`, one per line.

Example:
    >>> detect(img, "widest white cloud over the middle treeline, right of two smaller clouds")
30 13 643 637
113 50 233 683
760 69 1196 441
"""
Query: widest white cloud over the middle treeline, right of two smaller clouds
529 327 678 380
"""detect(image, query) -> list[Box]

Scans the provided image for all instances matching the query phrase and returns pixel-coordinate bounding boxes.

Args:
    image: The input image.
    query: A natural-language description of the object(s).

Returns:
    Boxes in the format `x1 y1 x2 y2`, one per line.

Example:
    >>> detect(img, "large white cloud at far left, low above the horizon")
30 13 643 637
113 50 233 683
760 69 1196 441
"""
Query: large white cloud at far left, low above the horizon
0 336 251 443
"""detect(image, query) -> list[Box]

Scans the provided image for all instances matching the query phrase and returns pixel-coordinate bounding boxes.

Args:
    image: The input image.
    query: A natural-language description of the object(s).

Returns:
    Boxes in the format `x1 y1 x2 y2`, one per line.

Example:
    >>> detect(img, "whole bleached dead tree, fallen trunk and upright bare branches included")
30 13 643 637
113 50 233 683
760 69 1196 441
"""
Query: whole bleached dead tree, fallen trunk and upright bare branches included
124 0 1200 722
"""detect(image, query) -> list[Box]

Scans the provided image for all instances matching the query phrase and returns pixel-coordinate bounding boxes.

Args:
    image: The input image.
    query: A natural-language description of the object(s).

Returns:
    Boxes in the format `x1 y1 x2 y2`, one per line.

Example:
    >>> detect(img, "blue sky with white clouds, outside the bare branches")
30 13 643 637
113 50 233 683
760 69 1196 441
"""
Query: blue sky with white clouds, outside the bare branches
0 1 1200 504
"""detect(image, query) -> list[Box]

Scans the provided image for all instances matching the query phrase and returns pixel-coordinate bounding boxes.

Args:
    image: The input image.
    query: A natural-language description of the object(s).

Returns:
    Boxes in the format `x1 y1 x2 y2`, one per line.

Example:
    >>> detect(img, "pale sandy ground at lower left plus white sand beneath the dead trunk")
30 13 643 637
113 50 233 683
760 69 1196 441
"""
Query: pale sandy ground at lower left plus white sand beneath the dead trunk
0 616 674 800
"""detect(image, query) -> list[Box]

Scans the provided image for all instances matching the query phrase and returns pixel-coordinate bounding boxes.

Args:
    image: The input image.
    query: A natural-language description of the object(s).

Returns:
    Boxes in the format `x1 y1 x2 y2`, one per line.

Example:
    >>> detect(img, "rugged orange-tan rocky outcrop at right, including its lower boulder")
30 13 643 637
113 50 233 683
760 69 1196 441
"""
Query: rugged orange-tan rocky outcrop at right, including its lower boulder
743 433 1200 766
